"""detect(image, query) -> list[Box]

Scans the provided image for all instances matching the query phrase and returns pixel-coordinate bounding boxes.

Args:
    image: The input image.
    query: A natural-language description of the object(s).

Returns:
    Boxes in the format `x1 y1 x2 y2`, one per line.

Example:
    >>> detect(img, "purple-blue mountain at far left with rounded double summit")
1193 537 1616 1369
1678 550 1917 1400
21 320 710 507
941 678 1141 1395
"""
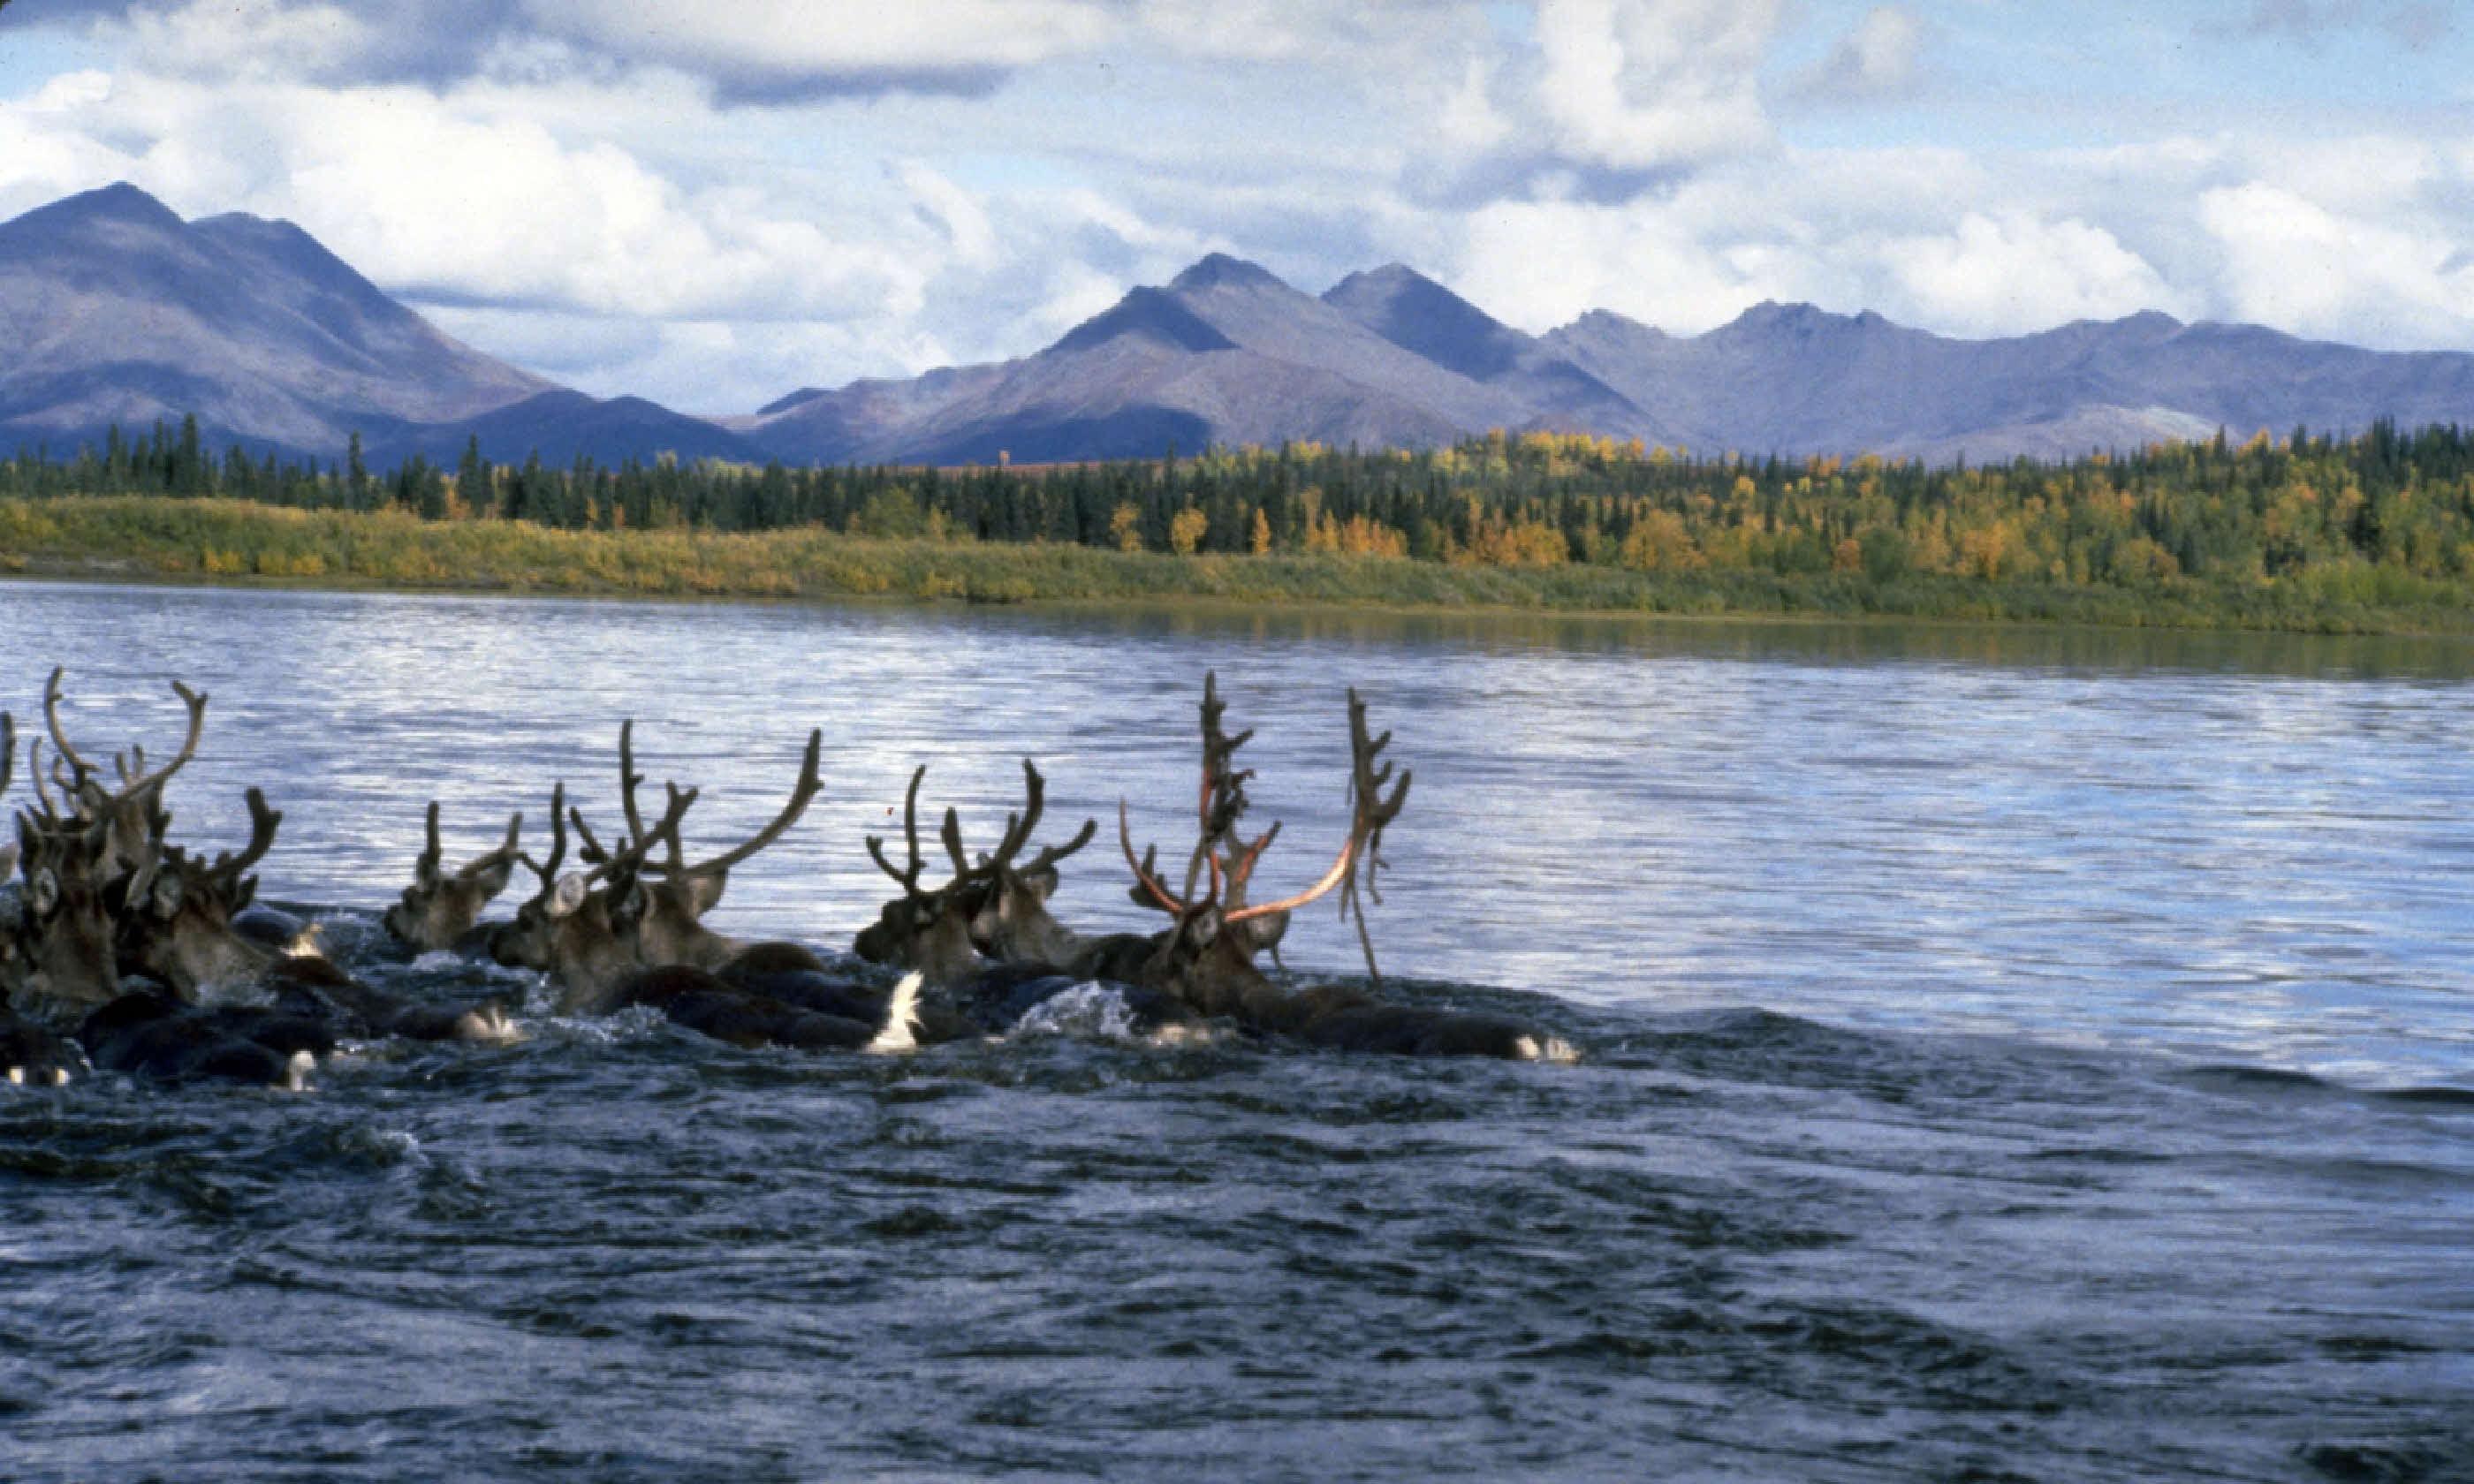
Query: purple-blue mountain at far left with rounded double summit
0 186 762 463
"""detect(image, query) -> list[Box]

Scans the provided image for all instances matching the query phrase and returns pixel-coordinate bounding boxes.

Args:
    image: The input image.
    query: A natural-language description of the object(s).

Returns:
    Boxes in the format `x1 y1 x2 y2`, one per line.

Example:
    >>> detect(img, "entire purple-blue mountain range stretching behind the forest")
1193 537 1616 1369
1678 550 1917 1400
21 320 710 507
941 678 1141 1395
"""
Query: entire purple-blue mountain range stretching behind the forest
0 186 2474 465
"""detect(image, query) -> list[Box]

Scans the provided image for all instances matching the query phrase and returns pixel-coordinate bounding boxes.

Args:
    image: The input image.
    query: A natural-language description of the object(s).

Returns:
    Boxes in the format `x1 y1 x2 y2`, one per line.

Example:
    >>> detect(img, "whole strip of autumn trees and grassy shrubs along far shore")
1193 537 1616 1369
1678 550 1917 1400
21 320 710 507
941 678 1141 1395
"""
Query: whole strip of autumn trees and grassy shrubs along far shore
0 423 2474 633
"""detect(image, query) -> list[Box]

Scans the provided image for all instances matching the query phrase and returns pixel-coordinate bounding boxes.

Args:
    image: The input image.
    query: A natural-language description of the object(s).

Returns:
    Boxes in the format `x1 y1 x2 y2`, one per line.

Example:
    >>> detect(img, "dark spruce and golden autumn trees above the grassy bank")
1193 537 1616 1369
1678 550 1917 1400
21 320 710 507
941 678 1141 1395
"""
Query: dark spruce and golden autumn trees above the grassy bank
14 418 2474 587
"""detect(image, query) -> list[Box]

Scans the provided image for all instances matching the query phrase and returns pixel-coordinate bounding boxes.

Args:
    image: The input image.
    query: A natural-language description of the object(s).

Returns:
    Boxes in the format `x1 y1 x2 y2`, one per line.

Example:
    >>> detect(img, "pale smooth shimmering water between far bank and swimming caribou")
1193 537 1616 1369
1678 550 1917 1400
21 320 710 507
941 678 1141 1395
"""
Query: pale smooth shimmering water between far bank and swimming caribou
0 584 2474 1083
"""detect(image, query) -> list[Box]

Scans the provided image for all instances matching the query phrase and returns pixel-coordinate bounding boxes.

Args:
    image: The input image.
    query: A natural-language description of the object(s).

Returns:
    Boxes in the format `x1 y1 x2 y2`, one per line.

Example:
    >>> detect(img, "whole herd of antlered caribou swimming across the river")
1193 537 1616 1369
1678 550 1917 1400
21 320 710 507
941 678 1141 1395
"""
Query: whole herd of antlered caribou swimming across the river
0 670 1574 1088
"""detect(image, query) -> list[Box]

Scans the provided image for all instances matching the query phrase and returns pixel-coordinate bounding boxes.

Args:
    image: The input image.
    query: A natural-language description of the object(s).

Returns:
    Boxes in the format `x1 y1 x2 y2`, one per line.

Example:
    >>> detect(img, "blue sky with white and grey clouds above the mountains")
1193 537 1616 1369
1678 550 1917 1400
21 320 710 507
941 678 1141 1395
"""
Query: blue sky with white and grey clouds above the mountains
0 0 2474 413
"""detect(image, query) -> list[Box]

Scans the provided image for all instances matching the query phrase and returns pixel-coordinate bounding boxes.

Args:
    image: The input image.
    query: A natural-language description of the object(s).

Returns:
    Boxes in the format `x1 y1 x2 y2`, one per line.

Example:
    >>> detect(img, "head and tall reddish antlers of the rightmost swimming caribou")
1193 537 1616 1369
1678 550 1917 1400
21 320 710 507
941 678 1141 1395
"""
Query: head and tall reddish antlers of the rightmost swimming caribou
1119 675 1410 1029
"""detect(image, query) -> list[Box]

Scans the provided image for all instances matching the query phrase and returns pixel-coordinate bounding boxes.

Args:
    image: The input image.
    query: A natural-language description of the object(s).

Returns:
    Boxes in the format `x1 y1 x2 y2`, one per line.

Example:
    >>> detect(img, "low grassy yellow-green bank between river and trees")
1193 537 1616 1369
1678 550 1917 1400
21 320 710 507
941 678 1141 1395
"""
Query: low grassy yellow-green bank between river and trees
0 495 2474 633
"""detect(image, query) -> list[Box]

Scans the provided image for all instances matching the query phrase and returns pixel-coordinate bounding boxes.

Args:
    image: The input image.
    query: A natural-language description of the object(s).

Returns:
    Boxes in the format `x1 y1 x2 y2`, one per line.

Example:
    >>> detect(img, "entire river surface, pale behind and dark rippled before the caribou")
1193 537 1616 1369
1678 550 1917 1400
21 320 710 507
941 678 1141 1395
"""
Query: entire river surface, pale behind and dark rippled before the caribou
0 584 2474 1479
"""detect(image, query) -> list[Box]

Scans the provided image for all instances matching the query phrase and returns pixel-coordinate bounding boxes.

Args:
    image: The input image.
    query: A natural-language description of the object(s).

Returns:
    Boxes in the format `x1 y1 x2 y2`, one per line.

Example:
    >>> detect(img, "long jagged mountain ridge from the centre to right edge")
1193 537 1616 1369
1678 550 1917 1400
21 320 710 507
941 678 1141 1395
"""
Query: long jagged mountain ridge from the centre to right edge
725 254 2474 463
